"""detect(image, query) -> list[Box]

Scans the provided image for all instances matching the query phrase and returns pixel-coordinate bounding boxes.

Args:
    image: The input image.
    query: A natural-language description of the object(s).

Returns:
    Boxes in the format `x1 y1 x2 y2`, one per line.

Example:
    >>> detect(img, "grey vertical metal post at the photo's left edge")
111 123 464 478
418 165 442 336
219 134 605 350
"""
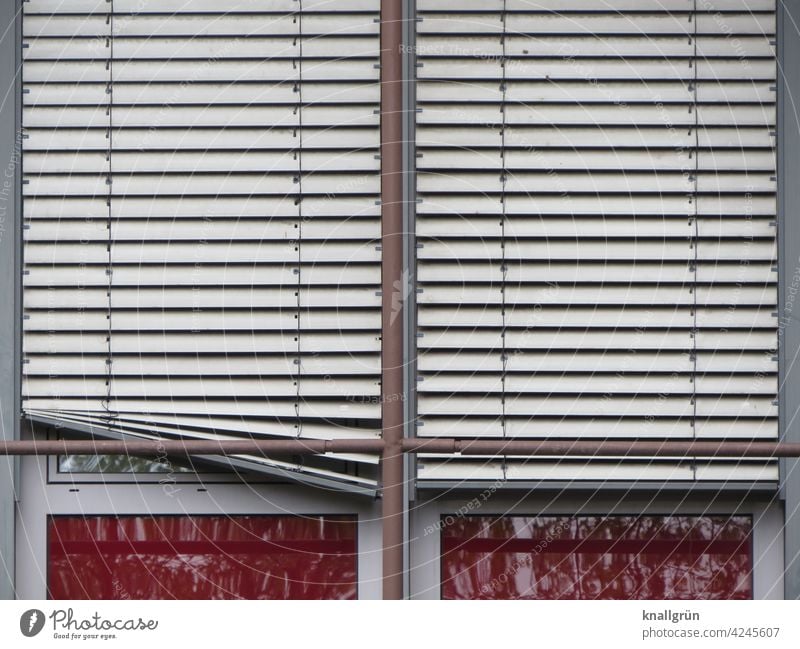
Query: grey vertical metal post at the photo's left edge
0 2 22 599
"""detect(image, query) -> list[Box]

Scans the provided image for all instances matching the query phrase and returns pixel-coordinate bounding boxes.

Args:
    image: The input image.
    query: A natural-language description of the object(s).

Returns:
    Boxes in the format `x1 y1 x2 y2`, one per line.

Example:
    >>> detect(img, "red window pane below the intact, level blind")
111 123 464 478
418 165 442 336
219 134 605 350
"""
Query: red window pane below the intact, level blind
442 516 752 599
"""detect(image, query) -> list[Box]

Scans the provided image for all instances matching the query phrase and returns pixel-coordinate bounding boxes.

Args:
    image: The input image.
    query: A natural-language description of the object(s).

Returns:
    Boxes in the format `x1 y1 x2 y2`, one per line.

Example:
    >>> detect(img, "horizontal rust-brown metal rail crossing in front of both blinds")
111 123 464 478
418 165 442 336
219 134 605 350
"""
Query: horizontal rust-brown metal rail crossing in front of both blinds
0 438 800 459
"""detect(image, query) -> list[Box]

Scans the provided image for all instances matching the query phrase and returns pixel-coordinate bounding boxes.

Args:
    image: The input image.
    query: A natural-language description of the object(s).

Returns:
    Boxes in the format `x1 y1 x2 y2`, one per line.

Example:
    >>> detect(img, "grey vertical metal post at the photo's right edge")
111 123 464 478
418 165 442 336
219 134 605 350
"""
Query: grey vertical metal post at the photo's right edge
776 0 800 599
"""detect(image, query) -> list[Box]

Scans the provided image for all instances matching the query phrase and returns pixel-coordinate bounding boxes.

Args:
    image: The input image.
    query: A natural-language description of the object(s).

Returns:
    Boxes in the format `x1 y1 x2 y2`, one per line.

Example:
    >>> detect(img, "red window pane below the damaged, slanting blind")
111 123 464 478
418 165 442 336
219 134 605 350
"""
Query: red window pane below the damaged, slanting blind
47 516 357 599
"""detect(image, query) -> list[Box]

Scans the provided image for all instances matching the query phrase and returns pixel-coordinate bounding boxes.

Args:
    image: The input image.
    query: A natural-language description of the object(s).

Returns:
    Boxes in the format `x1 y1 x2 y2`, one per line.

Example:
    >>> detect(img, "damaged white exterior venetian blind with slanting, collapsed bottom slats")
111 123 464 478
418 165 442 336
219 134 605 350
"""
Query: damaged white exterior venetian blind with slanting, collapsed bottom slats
23 0 380 489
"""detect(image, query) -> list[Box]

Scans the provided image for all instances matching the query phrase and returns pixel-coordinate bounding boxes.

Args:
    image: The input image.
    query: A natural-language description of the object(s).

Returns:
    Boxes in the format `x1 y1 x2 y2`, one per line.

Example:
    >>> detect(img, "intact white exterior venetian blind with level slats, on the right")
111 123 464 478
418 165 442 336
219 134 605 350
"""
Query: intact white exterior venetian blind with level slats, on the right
416 0 777 481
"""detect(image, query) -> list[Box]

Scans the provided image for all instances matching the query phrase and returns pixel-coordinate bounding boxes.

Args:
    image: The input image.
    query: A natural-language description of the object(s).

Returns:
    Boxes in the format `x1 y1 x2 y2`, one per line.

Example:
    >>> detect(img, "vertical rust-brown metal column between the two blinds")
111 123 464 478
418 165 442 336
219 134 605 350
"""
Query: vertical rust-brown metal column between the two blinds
381 0 407 599
